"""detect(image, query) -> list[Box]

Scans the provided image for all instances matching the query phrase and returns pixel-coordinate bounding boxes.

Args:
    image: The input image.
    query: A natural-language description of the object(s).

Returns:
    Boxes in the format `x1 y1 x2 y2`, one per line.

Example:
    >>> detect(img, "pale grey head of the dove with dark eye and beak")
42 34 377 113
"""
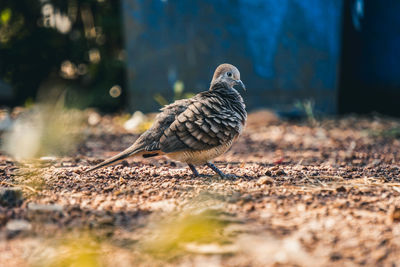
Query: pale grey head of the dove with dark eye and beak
211 63 246 90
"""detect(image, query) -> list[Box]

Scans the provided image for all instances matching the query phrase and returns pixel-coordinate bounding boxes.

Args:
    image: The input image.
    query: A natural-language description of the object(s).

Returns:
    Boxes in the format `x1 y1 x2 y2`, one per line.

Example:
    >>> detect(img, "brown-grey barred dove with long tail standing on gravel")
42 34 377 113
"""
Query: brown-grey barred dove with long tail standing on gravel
86 63 247 178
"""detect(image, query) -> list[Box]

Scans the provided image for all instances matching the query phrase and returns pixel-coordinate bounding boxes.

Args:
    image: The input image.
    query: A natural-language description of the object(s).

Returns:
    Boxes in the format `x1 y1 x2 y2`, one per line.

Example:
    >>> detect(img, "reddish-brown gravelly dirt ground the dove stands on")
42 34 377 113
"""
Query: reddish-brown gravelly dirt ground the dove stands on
0 111 400 266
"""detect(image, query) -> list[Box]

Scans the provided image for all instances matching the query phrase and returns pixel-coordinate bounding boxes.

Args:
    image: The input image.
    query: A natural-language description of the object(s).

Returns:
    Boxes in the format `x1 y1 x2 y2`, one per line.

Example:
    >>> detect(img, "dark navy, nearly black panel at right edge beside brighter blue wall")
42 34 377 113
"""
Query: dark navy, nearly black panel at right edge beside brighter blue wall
339 0 400 116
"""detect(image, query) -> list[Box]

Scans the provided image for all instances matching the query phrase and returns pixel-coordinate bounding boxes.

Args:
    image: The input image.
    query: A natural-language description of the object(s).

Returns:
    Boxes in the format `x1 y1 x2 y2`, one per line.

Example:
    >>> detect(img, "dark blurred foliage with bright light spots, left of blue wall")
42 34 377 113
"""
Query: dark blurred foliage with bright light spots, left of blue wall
0 0 125 111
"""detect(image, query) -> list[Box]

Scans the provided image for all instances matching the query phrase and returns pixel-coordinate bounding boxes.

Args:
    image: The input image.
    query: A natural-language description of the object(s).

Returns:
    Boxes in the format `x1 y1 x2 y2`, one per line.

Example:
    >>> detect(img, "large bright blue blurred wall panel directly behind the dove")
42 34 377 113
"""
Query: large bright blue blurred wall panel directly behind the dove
122 0 342 113
